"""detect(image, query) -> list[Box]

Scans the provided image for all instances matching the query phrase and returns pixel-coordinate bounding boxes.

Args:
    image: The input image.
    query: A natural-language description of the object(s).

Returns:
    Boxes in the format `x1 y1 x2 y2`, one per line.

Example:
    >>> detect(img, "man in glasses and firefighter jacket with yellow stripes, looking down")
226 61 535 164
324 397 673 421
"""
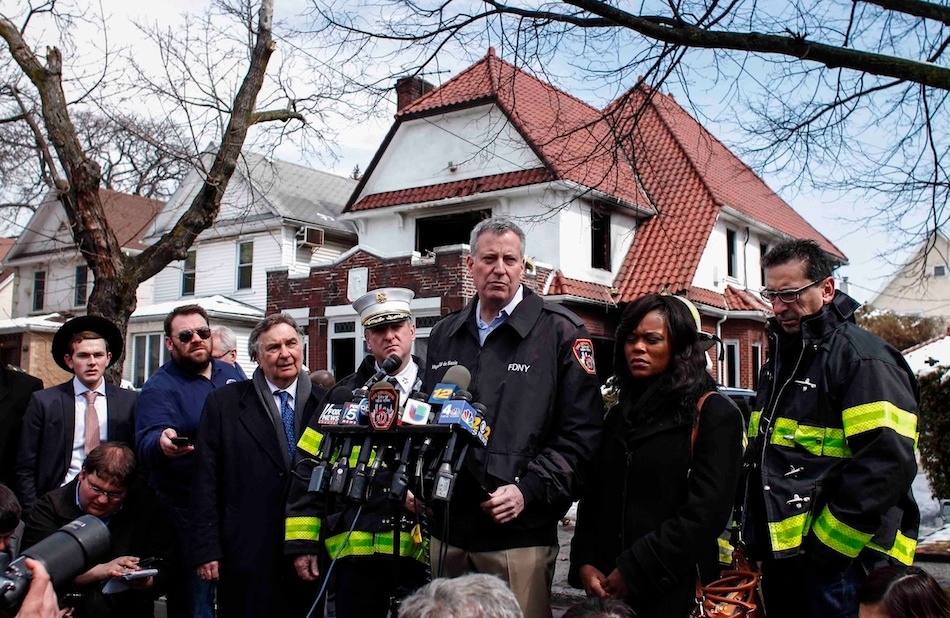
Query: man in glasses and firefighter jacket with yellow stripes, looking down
741 240 920 618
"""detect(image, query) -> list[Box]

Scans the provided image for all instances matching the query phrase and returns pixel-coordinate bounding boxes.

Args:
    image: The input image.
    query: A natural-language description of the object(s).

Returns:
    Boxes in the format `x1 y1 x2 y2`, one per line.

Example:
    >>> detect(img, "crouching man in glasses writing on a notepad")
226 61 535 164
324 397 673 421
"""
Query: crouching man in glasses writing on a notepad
23 442 172 618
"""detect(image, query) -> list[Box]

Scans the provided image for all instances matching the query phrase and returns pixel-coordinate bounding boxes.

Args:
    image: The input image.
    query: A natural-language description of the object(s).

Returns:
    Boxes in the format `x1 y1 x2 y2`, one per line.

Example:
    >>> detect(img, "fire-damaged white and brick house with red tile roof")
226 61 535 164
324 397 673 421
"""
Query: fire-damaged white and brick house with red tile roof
268 50 846 387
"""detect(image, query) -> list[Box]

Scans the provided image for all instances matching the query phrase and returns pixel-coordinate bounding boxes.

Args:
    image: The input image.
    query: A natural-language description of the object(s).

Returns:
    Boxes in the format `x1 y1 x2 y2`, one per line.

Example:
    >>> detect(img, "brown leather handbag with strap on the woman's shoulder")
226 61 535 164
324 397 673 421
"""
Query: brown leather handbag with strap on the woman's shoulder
690 391 761 618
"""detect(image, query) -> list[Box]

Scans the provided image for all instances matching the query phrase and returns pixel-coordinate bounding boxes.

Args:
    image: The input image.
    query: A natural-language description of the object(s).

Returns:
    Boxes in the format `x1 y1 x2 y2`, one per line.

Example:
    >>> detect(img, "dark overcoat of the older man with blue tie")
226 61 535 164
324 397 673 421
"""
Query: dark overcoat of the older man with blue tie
186 373 317 618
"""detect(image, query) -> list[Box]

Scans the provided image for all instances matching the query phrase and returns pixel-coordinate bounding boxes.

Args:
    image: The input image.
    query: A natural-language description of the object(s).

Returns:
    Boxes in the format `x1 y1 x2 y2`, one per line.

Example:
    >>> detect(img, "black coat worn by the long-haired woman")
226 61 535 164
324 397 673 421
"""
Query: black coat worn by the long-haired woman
569 395 743 618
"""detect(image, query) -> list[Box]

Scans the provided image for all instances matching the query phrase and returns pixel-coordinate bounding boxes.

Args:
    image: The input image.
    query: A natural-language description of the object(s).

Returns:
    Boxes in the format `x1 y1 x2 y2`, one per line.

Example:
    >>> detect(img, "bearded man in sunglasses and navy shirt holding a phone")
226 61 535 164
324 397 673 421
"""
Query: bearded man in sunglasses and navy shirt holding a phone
135 305 242 618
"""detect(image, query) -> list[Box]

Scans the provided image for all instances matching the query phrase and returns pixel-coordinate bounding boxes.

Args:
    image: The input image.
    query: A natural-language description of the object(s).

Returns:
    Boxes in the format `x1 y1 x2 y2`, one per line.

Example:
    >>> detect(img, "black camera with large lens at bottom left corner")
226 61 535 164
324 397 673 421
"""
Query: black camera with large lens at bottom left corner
0 515 110 615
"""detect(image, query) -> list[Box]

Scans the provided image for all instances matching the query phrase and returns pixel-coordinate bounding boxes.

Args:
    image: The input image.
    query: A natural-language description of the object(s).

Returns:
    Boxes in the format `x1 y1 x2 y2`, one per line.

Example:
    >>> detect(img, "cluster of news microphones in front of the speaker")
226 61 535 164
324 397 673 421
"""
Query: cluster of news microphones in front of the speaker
308 355 491 502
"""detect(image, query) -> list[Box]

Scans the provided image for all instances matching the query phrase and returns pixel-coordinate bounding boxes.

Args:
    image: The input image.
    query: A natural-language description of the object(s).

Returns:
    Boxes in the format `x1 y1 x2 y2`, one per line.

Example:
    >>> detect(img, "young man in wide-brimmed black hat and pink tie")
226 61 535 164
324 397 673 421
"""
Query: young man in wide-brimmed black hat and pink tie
16 315 137 513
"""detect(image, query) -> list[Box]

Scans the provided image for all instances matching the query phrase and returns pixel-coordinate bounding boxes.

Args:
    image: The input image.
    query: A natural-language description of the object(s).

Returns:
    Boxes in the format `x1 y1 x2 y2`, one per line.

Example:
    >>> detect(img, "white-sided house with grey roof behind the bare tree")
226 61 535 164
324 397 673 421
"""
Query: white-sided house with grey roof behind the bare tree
124 153 357 386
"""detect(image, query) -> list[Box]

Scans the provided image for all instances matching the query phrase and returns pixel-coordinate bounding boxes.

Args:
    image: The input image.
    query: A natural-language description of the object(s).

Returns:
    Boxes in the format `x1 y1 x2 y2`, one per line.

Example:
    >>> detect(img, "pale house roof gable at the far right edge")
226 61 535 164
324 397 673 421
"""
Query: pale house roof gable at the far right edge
868 231 950 322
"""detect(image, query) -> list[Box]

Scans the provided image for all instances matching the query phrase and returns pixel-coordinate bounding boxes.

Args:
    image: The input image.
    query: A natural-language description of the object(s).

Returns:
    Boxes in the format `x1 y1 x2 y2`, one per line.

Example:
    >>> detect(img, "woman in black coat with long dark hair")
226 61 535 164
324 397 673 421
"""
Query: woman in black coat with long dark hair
570 294 743 618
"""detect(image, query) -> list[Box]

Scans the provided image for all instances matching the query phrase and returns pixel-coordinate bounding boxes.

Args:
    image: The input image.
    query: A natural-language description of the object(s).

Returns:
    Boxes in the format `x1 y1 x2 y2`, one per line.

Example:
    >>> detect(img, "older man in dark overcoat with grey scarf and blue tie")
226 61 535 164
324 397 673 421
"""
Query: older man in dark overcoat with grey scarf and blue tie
189 314 318 616
